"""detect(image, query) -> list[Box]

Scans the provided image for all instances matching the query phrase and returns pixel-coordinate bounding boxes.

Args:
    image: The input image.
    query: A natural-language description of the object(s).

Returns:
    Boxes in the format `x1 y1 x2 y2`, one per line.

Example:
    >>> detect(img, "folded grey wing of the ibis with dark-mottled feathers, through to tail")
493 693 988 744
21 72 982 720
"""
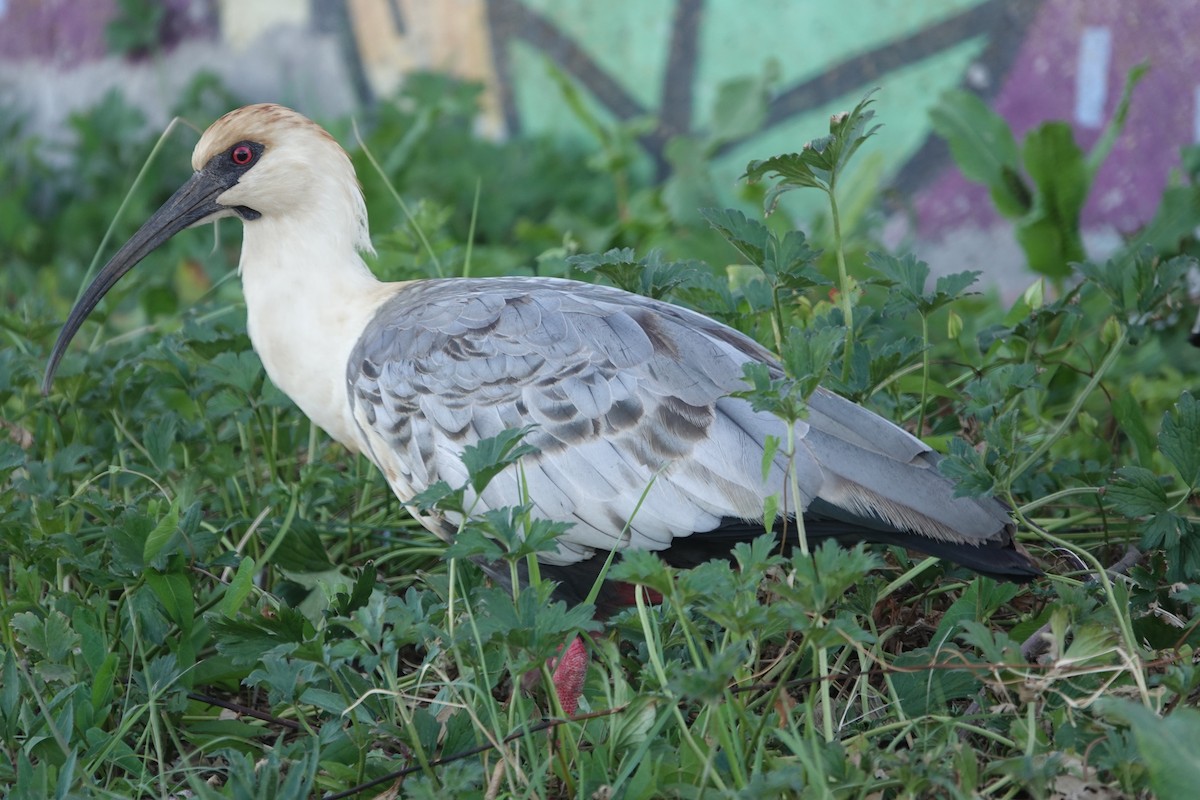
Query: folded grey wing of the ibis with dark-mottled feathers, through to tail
347 278 1008 564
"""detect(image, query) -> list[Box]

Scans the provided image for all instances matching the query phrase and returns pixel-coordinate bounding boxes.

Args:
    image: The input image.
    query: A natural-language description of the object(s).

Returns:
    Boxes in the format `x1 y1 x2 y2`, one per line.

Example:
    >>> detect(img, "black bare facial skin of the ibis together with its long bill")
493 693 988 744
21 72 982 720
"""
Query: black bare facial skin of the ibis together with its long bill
42 142 266 395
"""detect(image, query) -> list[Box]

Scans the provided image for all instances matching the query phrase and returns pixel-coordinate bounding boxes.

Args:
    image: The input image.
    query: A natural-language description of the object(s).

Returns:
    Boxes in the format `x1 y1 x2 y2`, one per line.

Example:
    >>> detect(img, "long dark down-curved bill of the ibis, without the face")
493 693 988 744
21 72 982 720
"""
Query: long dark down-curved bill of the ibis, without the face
42 169 230 395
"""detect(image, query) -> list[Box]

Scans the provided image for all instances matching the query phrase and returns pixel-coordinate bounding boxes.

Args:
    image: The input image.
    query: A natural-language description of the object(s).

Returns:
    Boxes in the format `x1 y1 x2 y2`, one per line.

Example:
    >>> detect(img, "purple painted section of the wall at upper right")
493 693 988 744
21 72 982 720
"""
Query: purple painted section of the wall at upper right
916 0 1200 236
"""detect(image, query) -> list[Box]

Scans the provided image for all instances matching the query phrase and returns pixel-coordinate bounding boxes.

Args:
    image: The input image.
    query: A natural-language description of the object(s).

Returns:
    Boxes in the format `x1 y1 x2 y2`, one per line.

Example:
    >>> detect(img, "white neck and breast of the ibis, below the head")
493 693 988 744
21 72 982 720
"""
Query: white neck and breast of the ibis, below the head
239 213 396 451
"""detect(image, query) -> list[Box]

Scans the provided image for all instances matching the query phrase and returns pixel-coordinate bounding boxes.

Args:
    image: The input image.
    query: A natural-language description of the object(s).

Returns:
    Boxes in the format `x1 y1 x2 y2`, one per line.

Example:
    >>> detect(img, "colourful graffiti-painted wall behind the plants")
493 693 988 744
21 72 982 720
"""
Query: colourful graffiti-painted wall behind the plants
0 0 1200 286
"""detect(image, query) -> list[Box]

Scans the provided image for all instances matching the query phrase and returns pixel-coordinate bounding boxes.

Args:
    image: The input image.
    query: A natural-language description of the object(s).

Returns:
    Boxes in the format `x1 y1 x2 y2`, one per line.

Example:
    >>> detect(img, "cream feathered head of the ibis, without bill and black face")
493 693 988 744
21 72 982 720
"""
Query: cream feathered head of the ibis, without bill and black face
192 103 371 251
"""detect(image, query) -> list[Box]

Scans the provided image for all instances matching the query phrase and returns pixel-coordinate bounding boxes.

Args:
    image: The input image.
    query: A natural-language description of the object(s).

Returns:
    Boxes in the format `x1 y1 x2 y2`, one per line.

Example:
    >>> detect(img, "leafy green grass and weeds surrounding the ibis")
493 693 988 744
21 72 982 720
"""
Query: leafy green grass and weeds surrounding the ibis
0 79 1200 799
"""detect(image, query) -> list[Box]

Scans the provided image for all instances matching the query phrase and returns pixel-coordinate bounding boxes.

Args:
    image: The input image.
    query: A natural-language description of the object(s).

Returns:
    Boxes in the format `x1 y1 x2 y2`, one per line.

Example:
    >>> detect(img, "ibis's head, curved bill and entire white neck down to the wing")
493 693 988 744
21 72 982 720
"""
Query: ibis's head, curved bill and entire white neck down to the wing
42 103 390 450
